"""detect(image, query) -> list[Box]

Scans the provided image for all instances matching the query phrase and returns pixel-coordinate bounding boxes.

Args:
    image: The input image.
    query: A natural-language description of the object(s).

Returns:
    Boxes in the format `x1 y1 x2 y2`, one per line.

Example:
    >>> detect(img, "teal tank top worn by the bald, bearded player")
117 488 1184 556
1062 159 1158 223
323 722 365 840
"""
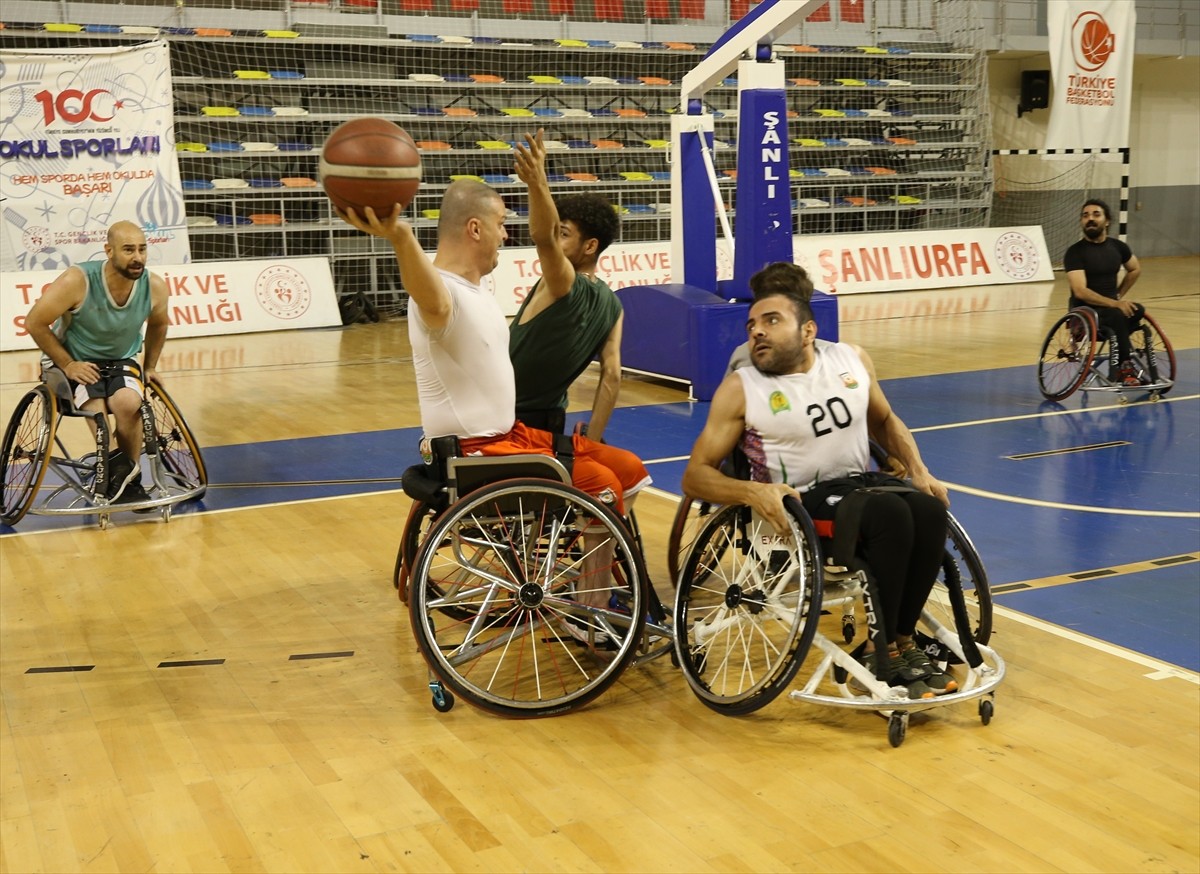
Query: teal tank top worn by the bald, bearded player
62 261 151 361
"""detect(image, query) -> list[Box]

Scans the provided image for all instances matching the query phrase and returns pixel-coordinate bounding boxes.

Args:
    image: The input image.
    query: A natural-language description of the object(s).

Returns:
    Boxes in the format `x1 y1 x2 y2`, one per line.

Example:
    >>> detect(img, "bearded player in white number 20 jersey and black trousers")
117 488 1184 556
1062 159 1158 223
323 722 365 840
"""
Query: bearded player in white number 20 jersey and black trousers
683 264 958 699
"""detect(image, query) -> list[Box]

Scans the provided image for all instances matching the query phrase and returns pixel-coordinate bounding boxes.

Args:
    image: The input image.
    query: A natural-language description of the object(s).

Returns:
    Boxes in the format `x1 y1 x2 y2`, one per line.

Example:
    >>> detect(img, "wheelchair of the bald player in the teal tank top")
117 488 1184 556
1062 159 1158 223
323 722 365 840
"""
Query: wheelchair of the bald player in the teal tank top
0 369 209 528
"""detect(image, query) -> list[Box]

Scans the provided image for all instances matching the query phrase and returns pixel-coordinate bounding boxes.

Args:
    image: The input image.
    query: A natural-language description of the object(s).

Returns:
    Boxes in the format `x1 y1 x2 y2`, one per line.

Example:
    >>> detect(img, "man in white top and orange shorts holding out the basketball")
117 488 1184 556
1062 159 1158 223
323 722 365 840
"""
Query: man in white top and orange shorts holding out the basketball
342 179 650 606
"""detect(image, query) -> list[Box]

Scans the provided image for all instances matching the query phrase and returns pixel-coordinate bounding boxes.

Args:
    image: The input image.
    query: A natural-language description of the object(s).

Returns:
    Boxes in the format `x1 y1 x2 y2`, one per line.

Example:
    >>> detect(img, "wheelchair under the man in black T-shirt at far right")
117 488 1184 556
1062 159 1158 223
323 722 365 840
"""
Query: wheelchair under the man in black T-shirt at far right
1038 306 1175 403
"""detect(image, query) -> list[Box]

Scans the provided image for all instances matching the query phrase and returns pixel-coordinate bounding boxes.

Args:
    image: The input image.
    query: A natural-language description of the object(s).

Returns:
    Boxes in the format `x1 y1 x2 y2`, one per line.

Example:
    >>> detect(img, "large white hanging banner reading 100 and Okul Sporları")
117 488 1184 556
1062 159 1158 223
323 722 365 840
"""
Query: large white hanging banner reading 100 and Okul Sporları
0 42 191 271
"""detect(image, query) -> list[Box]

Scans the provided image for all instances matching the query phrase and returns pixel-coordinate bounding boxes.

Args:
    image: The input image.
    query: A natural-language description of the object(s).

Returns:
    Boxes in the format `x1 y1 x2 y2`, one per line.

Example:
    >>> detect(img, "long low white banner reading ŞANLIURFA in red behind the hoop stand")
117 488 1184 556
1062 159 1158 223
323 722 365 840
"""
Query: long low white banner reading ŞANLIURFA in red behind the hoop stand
484 225 1054 316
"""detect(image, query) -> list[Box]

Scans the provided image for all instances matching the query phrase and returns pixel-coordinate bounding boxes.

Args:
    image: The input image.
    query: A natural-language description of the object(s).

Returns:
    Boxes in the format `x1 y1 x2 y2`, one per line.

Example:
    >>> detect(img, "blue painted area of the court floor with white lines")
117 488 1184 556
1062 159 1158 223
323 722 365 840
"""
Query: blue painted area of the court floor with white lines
0 349 1200 670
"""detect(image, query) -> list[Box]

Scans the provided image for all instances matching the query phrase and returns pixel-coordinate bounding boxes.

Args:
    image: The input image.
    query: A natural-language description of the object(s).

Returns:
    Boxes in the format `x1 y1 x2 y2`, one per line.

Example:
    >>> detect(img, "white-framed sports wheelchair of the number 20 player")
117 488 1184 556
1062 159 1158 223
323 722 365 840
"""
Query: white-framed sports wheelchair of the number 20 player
668 450 1004 747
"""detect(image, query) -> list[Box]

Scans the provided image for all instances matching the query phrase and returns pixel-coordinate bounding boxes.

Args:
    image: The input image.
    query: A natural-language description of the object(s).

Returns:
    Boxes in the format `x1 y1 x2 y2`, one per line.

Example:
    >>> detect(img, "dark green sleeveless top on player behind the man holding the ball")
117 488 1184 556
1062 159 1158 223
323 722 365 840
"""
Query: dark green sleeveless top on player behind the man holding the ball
509 274 620 411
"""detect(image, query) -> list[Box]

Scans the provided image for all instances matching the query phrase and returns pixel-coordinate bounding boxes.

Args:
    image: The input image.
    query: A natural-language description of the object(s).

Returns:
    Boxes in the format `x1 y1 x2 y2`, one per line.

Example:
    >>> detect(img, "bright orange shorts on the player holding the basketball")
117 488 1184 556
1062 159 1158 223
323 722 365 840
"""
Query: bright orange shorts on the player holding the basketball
460 421 650 515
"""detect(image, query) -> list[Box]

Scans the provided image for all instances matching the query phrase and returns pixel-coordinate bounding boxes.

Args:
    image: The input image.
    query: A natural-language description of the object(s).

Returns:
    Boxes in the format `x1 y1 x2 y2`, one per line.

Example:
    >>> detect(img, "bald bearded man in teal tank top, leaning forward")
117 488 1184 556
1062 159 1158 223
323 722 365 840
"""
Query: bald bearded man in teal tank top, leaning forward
25 221 168 502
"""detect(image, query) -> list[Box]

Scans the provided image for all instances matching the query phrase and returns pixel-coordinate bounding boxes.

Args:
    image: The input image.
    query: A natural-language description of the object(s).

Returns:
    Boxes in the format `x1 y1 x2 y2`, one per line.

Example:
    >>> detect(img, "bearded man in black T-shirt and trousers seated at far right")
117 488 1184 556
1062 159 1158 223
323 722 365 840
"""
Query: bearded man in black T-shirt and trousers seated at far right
1062 199 1146 385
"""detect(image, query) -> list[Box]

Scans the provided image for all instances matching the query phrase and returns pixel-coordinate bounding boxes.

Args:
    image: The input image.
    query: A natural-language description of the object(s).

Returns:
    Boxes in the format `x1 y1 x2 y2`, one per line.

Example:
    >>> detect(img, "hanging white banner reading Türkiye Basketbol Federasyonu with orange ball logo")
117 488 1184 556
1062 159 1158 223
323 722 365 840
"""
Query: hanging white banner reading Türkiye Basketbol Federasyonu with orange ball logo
1045 0 1138 149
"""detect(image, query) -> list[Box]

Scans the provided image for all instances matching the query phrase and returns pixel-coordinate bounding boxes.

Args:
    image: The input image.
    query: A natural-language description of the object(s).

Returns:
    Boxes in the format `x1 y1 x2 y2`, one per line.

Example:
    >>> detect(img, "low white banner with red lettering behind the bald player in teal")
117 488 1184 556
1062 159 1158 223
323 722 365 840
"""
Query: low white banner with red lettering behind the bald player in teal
0 258 342 352
